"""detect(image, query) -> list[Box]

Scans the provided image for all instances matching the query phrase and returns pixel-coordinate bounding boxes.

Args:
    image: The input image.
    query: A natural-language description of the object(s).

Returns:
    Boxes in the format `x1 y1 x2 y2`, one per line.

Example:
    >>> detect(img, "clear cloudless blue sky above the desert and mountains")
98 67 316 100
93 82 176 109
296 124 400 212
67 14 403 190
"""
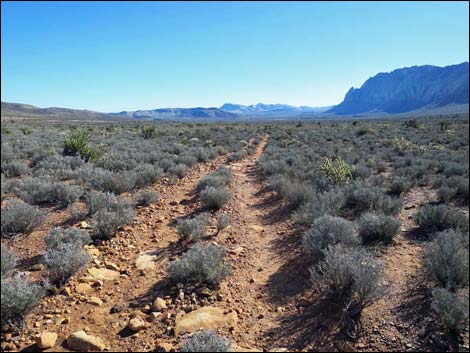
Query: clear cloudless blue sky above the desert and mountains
1 1 469 112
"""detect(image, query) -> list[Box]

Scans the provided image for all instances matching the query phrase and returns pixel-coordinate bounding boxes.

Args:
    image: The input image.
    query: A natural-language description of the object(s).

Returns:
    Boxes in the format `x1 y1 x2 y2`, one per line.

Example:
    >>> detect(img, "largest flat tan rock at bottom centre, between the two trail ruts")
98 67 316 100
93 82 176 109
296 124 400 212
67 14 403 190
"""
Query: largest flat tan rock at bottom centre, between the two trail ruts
175 306 238 336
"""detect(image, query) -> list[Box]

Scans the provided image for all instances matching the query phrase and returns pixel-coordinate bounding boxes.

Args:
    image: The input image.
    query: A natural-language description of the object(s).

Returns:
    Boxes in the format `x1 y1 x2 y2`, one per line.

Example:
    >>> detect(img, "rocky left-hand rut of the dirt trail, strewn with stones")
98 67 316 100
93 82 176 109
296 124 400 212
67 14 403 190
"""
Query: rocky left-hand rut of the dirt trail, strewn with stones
17 150 239 351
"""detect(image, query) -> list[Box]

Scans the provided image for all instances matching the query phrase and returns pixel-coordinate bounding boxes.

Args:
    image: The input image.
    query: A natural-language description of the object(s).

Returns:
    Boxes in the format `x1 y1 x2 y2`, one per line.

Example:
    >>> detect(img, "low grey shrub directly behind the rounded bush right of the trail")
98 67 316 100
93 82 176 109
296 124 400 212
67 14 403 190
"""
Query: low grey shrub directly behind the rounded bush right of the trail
294 189 346 225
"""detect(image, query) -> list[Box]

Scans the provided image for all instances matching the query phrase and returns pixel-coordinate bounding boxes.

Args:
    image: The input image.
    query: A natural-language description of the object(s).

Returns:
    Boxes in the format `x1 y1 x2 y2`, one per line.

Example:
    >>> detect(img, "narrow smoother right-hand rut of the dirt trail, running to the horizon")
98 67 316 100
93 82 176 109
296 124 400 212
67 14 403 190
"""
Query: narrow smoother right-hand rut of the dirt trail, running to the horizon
214 134 298 349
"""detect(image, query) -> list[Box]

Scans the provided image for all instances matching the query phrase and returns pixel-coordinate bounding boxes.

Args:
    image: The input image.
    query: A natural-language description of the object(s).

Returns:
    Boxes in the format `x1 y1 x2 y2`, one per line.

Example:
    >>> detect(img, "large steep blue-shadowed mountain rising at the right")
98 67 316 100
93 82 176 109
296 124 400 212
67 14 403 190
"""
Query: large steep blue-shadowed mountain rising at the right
327 62 469 115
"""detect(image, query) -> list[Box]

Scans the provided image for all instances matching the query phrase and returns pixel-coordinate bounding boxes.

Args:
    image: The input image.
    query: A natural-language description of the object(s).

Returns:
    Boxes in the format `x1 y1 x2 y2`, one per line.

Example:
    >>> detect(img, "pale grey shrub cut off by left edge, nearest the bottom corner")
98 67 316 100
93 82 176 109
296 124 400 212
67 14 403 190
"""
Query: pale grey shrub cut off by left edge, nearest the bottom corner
1 274 46 326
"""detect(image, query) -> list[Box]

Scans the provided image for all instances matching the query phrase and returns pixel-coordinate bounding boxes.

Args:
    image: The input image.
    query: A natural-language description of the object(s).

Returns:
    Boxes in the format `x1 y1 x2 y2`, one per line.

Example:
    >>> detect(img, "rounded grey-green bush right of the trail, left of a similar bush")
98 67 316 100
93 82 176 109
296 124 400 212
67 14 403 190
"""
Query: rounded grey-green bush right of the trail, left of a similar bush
302 215 357 263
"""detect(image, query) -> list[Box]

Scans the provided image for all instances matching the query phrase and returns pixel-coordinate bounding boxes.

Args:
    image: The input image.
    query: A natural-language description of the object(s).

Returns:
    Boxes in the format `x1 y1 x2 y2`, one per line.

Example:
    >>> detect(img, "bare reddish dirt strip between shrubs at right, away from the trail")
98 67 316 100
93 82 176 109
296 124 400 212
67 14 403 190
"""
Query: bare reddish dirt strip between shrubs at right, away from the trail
356 187 436 351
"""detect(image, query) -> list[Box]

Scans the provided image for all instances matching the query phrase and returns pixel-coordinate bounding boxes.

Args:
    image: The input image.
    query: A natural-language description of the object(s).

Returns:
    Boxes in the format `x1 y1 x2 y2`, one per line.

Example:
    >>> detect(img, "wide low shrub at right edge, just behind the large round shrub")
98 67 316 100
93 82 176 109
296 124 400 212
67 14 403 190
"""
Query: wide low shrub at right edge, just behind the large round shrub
415 204 468 237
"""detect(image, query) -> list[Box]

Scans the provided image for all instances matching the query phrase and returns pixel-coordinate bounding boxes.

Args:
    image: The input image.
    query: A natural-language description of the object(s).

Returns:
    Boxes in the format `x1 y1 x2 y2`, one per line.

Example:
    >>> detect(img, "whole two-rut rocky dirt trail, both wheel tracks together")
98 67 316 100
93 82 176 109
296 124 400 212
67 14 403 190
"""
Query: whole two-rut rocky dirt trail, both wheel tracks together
16 136 296 351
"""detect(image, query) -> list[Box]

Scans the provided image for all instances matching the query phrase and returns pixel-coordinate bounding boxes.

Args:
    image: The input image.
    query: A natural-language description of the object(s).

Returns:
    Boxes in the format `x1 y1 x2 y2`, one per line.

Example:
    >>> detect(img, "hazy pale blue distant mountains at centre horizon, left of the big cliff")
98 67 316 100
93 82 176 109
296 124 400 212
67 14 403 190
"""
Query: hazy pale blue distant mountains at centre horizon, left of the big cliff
220 103 331 117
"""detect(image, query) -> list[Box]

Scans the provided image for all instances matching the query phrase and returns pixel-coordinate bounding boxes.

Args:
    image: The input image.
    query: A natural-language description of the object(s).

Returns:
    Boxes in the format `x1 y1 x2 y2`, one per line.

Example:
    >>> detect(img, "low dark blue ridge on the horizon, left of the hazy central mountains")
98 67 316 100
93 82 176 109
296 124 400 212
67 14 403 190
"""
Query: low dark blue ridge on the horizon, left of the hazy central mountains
111 107 238 119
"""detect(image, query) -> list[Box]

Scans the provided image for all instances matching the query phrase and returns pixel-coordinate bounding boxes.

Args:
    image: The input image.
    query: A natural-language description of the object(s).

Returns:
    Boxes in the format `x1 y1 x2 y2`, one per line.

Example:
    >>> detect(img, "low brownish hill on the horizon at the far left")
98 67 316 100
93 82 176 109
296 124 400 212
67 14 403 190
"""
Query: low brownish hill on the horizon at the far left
1 102 117 120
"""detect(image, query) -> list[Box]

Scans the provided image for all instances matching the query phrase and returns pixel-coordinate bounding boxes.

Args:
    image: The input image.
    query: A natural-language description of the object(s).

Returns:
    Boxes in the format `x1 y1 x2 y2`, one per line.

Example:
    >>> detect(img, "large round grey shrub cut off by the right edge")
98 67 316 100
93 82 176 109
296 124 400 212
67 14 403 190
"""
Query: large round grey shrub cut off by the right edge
423 230 469 291
